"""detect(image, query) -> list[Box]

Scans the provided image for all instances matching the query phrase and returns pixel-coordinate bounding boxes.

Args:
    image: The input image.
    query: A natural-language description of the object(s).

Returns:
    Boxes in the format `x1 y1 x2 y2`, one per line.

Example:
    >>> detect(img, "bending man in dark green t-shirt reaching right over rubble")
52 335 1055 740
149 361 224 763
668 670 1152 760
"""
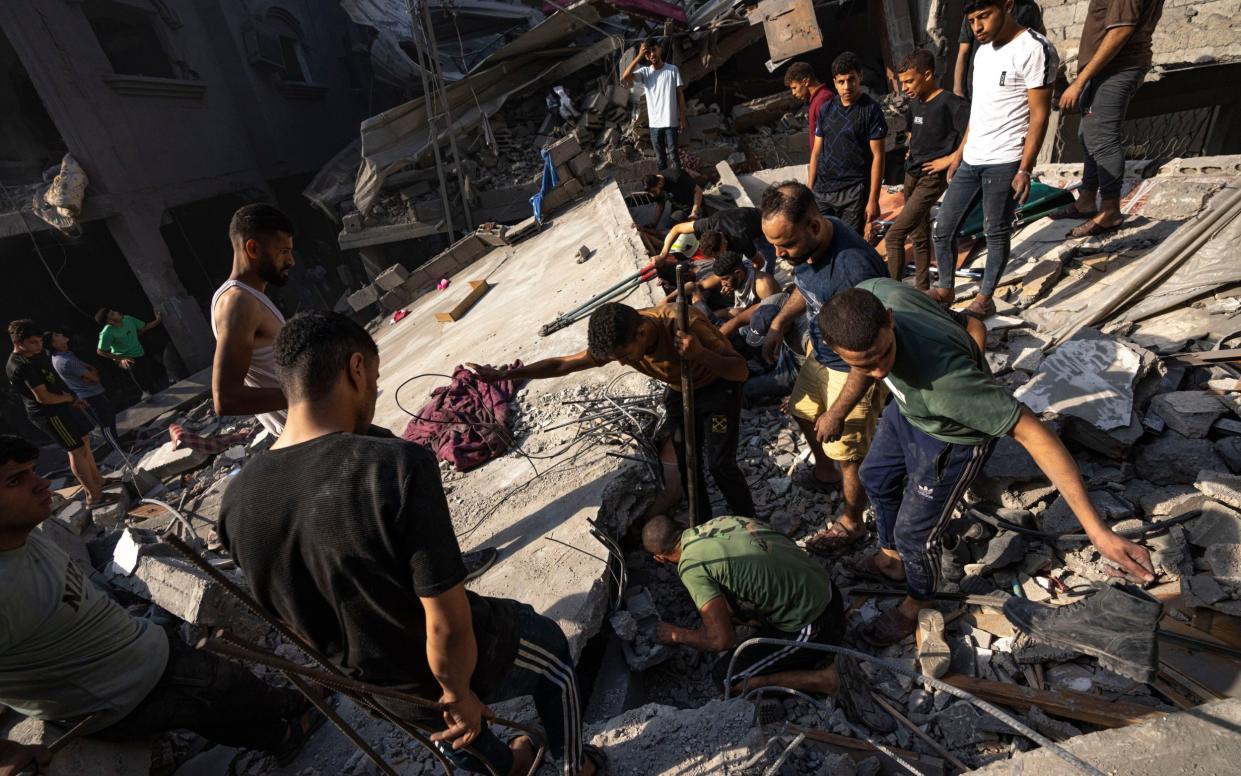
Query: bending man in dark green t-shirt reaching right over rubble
819 278 1154 646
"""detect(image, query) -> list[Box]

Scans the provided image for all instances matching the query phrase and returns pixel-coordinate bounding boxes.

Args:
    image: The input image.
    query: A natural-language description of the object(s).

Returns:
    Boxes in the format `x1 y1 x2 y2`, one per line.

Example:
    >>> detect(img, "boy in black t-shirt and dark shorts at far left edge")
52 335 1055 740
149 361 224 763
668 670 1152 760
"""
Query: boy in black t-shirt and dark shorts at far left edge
5 318 104 507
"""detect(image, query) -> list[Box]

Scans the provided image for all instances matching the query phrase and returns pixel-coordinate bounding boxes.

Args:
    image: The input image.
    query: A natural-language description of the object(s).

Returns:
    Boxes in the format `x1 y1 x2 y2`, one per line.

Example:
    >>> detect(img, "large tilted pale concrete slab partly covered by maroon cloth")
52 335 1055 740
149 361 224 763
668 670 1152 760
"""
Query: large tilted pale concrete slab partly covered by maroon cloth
375 184 653 654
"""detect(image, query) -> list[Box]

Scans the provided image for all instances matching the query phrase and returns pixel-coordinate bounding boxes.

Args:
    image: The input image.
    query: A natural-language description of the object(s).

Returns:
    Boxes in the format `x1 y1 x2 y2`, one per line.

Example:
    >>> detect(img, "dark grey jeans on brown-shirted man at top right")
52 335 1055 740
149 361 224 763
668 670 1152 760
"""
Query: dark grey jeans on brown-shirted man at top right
1077 67 1147 200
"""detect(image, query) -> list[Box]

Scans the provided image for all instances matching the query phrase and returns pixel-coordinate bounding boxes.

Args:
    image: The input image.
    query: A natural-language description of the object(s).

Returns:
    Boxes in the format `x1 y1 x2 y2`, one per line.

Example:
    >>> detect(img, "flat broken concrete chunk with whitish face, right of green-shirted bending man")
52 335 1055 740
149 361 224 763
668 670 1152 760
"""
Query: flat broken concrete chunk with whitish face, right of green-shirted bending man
1014 329 1143 431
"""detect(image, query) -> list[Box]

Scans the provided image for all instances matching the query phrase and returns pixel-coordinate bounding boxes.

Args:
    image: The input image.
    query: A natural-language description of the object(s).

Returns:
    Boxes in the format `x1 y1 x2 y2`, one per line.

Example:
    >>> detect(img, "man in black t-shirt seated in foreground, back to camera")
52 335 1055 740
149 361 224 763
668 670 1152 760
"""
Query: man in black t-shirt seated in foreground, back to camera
220 312 599 776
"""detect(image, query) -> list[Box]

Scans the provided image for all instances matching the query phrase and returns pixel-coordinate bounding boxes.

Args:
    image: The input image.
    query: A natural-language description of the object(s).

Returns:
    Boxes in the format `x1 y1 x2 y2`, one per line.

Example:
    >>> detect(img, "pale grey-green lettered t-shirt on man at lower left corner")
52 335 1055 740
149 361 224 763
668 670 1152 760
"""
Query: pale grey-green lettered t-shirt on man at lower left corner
0 528 168 733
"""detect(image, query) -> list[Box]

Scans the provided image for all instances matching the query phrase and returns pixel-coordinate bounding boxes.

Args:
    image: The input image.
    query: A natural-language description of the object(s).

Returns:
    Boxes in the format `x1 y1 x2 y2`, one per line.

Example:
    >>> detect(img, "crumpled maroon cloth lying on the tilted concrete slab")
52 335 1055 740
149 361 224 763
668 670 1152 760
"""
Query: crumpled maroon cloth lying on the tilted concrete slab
401 361 521 472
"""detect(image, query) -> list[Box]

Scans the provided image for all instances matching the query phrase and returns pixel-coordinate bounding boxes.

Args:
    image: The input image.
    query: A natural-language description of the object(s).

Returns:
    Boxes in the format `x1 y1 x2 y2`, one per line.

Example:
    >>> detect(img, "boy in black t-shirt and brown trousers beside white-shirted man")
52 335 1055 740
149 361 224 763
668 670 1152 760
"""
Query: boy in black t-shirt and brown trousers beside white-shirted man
885 48 969 291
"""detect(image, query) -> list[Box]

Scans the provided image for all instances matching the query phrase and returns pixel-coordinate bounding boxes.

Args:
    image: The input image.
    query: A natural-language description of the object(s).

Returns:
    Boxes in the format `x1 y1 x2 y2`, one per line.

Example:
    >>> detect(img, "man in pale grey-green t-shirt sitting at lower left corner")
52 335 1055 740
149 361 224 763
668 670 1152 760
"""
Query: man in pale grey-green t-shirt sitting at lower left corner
0 435 323 765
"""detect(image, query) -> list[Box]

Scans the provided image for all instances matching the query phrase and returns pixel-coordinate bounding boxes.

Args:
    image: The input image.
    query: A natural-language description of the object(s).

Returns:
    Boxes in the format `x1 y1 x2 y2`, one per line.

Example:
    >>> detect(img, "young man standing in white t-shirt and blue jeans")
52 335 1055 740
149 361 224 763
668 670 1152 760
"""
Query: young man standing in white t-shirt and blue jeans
930 0 1060 318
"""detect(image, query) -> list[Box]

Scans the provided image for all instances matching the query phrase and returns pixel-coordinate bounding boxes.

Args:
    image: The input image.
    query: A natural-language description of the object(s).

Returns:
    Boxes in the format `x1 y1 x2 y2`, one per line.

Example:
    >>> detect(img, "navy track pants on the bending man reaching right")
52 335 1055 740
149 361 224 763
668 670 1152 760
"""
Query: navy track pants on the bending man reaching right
860 401 995 601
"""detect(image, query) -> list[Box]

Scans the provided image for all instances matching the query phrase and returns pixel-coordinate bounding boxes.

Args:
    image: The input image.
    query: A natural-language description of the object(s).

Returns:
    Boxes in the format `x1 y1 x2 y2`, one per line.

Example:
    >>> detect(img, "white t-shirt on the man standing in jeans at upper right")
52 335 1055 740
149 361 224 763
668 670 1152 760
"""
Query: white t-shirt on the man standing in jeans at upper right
963 30 1060 165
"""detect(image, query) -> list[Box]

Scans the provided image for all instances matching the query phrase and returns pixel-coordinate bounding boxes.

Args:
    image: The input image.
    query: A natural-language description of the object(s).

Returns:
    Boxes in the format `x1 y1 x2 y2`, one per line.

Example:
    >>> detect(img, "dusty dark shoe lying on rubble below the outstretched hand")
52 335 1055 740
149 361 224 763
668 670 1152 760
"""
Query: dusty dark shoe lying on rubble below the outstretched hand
1004 585 1163 684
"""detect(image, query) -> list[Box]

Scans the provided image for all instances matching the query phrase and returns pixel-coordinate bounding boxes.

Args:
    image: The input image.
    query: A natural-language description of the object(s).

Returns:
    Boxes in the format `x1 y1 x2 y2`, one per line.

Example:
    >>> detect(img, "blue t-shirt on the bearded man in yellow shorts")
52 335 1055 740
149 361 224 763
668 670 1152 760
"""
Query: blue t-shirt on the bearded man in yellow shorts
793 216 887 371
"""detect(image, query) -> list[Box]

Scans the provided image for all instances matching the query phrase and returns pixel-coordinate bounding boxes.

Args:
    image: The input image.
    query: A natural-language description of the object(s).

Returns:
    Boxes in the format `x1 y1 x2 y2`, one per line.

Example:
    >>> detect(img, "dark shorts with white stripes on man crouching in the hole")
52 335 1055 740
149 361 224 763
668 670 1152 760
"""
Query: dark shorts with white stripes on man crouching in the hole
711 584 845 688
